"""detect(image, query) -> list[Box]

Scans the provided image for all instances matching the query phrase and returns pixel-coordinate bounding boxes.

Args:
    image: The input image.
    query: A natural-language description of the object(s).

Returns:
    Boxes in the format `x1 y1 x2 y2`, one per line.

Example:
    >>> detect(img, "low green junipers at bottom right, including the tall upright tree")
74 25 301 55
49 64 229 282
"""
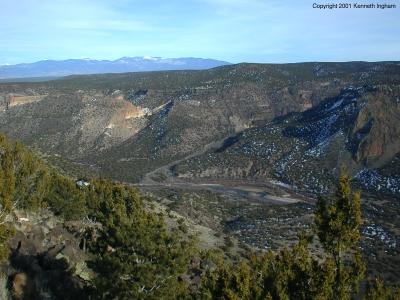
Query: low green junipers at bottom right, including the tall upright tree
199 175 365 300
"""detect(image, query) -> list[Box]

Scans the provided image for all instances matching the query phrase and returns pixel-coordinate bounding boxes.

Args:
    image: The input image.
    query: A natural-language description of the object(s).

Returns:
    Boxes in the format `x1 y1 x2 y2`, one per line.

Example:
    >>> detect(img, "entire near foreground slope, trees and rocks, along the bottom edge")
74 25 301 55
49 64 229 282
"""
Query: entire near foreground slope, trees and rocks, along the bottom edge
0 135 399 299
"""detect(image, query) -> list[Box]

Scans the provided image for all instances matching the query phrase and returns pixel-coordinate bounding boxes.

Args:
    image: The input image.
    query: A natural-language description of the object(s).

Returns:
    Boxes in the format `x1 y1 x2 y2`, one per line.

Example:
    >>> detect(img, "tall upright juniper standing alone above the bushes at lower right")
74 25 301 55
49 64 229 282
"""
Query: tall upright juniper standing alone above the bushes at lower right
315 175 365 299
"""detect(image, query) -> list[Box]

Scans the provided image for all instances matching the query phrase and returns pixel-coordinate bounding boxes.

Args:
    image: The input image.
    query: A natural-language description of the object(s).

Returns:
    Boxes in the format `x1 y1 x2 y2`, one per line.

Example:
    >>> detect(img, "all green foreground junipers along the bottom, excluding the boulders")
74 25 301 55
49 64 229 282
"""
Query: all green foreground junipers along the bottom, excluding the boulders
0 136 400 299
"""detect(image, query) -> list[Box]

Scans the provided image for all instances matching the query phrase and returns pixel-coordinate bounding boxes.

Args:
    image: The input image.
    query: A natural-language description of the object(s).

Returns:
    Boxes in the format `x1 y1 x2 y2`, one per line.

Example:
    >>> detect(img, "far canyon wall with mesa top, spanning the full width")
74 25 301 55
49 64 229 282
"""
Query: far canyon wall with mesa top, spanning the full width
0 62 400 191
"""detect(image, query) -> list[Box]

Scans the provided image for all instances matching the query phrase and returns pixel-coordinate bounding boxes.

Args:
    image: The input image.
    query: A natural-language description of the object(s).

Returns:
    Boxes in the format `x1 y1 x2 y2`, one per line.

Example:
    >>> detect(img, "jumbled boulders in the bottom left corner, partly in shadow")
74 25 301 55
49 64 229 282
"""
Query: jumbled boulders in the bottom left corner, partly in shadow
6 211 99 300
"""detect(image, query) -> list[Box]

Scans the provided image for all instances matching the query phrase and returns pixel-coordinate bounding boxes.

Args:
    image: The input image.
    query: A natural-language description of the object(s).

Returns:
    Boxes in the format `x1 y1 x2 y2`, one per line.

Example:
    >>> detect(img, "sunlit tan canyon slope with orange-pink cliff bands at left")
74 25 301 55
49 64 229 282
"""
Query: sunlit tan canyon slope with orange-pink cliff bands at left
0 90 146 158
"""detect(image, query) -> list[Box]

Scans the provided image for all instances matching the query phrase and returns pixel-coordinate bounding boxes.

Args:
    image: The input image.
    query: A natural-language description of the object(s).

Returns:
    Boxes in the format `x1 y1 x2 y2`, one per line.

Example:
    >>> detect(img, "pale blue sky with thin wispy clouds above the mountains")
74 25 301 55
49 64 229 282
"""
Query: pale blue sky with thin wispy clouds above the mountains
0 0 400 64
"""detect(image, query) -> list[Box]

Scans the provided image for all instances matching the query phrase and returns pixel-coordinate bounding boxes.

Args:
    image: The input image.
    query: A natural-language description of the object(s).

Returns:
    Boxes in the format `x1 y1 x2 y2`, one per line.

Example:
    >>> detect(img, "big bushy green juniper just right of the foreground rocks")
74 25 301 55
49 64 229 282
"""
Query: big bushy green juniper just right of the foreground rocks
90 182 192 299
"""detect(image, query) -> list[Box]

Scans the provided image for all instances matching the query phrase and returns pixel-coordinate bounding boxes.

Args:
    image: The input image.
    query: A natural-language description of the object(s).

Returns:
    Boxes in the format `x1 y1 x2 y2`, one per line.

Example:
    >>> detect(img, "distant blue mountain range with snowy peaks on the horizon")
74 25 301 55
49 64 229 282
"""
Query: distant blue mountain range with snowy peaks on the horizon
0 56 230 79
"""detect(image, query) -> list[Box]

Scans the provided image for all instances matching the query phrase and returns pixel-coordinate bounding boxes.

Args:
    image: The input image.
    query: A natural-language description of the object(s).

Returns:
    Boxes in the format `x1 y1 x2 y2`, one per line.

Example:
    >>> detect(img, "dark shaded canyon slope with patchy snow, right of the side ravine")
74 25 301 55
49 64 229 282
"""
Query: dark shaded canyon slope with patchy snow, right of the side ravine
172 87 400 195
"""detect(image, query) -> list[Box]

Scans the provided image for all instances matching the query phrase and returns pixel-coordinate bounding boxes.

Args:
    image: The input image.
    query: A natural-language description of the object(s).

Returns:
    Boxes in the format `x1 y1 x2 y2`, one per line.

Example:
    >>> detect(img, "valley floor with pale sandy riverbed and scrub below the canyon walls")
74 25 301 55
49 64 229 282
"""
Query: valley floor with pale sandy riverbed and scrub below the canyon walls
136 165 400 282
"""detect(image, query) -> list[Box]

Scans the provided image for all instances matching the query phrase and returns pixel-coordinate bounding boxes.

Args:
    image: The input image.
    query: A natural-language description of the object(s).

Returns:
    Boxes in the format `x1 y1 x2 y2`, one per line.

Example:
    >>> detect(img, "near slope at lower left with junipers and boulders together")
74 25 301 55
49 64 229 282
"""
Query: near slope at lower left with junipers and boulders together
0 135 198 300
